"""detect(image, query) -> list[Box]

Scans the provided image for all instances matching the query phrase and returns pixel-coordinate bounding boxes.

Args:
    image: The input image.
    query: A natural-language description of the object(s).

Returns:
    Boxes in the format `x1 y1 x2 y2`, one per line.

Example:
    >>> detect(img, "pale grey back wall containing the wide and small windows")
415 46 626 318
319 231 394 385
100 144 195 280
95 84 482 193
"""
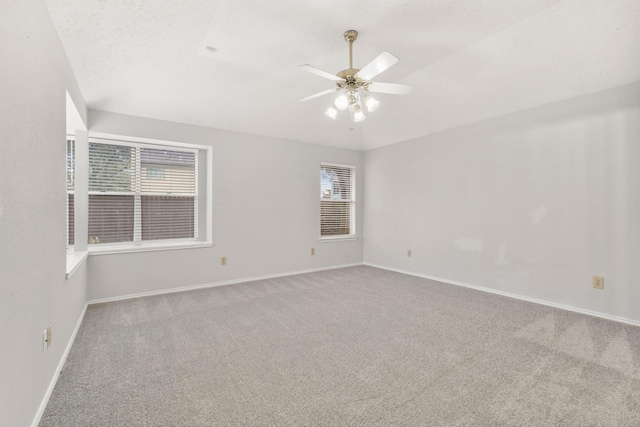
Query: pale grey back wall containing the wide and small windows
89 110 363 300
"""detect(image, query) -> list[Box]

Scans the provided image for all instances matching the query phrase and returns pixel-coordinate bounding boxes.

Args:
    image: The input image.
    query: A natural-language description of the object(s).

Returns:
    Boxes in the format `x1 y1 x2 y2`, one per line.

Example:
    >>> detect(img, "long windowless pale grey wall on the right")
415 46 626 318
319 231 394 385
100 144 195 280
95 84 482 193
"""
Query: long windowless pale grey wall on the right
364 83 640 322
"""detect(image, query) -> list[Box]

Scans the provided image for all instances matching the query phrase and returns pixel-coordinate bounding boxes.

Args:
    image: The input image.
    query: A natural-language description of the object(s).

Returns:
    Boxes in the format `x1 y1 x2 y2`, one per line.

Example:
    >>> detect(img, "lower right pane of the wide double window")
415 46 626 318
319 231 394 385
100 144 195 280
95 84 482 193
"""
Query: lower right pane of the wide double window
142 196 195 240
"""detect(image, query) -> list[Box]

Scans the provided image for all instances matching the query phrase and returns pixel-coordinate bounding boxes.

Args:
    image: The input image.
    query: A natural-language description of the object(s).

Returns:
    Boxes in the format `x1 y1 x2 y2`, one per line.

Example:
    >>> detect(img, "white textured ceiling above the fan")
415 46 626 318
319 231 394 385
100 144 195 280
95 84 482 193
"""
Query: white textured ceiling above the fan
46 0 640 149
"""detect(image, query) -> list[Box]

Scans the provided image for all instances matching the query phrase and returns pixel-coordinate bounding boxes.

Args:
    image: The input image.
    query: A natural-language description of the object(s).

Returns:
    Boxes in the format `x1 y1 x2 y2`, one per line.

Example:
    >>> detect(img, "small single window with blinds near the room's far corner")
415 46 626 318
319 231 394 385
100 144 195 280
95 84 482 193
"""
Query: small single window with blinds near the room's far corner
320 163 356 239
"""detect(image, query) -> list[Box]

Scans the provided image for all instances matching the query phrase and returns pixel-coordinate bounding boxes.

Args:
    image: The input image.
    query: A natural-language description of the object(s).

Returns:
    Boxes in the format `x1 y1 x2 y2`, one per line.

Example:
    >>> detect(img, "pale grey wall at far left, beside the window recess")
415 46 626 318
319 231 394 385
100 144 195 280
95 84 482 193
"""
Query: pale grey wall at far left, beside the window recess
0 0 86 426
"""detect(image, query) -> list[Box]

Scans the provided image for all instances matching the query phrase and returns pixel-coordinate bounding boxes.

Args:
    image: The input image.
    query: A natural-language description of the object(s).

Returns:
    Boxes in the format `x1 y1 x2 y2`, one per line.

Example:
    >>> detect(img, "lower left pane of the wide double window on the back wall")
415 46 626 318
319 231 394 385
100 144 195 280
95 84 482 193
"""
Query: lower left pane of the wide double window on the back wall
89 194 135 244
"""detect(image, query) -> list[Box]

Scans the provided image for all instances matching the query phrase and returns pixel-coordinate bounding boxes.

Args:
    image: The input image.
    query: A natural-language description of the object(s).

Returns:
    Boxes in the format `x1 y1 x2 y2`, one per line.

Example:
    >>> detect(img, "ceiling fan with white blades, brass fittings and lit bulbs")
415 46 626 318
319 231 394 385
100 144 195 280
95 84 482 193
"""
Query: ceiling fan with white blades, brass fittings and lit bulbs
298 30 413 122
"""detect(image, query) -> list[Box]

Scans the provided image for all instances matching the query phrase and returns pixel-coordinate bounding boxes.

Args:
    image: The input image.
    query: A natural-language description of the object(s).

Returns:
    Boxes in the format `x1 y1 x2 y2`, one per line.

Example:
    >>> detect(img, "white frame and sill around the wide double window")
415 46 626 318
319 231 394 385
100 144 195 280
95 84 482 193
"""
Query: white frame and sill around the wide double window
84 132 213 255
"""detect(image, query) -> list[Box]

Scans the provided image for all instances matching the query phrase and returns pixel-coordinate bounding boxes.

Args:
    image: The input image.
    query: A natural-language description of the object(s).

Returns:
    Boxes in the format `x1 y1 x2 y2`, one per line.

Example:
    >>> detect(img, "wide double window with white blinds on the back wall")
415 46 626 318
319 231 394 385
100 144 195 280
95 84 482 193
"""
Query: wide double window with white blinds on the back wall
88 138 200 247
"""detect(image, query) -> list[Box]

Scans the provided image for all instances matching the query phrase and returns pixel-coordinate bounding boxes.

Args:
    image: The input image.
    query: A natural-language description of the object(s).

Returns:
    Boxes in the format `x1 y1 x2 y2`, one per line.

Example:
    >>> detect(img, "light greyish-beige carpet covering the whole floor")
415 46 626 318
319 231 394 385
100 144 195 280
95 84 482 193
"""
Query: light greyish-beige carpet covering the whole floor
40 267 640 427
